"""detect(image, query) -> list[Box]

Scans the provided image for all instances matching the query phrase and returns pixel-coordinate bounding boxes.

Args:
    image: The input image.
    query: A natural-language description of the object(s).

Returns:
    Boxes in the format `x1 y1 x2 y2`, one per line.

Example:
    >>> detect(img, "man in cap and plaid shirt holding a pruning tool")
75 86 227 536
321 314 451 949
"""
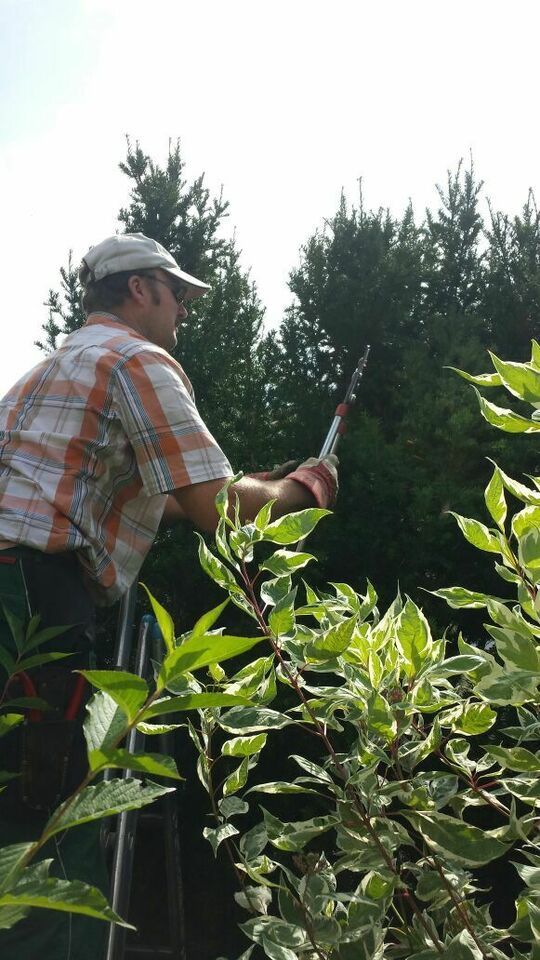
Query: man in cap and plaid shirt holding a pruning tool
0 234 337 960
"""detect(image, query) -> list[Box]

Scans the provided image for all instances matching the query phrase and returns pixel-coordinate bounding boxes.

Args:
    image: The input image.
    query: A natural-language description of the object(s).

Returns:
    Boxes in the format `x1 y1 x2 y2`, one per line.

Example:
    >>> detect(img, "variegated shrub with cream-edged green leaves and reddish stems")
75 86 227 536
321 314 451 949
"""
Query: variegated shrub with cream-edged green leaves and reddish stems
175 343 540 960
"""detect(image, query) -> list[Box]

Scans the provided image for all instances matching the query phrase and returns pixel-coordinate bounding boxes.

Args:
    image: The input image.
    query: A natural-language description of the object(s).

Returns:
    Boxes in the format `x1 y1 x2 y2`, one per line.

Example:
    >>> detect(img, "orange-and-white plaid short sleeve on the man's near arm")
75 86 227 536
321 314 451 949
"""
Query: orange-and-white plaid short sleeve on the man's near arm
114 348 233 496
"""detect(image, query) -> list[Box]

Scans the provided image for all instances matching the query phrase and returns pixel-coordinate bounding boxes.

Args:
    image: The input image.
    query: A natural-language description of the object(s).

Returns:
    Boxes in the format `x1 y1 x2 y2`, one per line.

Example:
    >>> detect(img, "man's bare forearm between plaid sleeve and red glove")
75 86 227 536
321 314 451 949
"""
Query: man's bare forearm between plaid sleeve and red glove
171 477 316 533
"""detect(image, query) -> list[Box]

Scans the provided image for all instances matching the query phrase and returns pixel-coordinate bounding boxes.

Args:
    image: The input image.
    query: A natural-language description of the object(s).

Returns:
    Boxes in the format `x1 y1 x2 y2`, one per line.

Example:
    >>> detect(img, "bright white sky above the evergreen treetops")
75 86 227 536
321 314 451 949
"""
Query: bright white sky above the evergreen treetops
0 0 540 393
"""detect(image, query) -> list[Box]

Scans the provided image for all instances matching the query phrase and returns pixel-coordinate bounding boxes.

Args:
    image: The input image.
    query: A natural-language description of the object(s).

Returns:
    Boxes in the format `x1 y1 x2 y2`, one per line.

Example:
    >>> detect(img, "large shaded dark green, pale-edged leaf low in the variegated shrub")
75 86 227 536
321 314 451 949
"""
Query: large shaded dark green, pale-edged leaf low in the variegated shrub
403 811 508 867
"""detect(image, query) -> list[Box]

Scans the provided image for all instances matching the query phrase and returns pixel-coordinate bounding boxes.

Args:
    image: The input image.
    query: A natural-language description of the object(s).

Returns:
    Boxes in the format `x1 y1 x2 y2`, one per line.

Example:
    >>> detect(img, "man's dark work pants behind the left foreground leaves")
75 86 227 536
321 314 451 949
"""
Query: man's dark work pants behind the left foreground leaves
0 547 107 960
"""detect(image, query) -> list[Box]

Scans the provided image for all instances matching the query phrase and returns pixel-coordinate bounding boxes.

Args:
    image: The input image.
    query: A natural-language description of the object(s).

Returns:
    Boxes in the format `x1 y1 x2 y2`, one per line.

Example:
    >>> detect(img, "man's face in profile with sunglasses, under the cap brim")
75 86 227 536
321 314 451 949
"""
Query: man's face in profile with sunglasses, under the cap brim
141 270 188 352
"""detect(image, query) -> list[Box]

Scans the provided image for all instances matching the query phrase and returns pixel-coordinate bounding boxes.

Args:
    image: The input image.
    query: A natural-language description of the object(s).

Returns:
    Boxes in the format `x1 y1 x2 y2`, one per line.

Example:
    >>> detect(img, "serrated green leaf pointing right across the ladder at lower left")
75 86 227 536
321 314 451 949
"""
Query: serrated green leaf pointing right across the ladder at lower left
47 774 174 836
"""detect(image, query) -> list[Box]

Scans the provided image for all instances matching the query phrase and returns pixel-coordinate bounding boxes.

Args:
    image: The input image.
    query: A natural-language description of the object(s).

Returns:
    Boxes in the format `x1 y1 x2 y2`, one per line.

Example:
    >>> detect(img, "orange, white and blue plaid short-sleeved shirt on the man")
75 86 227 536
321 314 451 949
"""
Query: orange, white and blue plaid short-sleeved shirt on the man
0 313 232 603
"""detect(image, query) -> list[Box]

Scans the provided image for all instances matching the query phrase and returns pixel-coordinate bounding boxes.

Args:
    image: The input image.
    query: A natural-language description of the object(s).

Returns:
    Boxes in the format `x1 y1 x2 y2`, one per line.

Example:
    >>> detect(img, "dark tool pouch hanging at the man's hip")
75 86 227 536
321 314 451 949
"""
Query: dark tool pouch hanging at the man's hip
17 719 84 810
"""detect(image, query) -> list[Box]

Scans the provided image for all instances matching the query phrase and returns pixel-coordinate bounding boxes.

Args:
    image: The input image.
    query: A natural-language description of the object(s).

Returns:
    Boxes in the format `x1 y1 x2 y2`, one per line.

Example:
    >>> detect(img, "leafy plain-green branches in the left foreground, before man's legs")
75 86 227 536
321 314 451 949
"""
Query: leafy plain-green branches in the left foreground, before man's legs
0 598 259 929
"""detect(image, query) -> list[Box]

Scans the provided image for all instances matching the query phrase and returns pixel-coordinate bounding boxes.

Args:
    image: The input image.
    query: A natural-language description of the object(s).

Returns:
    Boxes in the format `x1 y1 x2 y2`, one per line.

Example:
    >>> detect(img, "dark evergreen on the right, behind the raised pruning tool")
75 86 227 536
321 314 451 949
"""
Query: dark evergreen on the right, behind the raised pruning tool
275 165 538 616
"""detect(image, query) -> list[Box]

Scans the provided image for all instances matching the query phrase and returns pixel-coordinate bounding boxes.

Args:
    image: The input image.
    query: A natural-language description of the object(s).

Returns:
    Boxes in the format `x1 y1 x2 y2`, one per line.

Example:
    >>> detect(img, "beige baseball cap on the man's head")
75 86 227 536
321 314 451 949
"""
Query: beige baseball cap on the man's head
79 233 210 299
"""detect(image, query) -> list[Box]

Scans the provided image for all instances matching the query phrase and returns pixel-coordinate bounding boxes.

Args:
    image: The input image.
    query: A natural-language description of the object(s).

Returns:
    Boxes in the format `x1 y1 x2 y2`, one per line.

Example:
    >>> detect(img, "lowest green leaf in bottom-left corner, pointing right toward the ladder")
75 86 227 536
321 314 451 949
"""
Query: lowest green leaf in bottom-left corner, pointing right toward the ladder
0 877 131 930
